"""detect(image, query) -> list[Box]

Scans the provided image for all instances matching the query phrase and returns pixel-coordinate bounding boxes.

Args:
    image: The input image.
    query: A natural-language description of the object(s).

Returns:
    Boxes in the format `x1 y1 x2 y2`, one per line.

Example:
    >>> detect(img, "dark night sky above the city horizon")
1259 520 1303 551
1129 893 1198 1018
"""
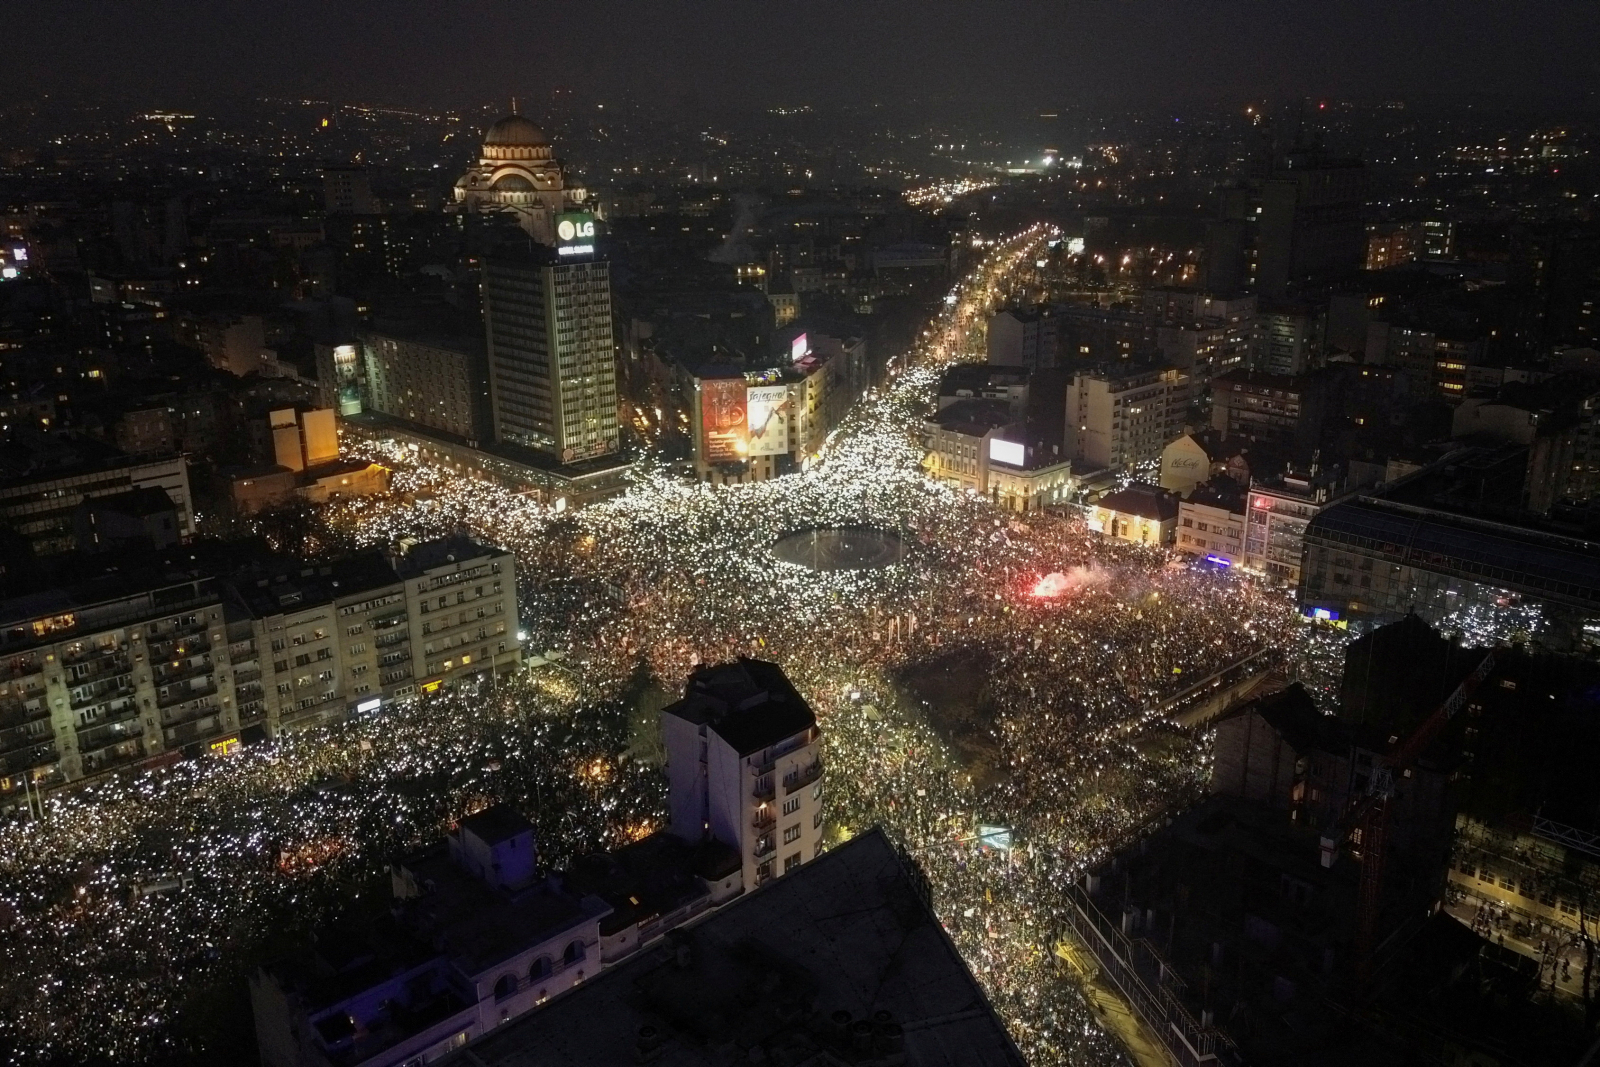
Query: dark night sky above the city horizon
9 0 1600 106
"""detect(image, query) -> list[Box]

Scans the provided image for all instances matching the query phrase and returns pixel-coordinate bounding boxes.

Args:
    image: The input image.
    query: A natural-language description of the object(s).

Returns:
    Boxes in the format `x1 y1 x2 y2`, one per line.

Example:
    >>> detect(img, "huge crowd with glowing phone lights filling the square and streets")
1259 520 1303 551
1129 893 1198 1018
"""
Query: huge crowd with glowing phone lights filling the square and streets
0 227 1338 1064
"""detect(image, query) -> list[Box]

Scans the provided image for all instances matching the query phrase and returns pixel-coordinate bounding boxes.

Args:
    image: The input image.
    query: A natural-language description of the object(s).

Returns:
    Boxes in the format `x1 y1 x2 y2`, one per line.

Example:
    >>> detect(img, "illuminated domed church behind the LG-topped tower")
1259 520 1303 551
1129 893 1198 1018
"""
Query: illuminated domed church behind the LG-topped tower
456 101 586 245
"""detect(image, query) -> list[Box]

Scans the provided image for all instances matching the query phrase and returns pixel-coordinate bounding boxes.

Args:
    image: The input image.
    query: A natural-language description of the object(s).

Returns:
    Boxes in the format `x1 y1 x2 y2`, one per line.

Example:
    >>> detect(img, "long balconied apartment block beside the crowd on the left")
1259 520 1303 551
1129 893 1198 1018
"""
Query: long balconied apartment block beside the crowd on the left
0 537 520 809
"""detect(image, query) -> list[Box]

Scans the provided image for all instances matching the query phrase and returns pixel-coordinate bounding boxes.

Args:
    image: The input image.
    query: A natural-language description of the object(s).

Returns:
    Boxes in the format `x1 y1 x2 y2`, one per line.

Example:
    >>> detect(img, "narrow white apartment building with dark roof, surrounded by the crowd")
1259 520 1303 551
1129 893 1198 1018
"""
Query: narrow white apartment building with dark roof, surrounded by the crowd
661 659 822 888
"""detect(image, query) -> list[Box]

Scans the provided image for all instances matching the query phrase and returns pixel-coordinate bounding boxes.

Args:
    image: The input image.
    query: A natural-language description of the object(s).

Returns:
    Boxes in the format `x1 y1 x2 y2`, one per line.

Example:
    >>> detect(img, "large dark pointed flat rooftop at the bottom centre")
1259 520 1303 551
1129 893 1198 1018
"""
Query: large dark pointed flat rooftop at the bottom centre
446 829 1022 1067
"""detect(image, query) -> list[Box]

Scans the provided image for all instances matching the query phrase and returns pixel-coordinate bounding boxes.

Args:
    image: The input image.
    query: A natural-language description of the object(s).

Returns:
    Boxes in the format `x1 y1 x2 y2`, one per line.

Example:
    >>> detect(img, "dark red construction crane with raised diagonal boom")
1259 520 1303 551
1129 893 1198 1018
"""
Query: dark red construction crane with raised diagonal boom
1322 651 1494 979
